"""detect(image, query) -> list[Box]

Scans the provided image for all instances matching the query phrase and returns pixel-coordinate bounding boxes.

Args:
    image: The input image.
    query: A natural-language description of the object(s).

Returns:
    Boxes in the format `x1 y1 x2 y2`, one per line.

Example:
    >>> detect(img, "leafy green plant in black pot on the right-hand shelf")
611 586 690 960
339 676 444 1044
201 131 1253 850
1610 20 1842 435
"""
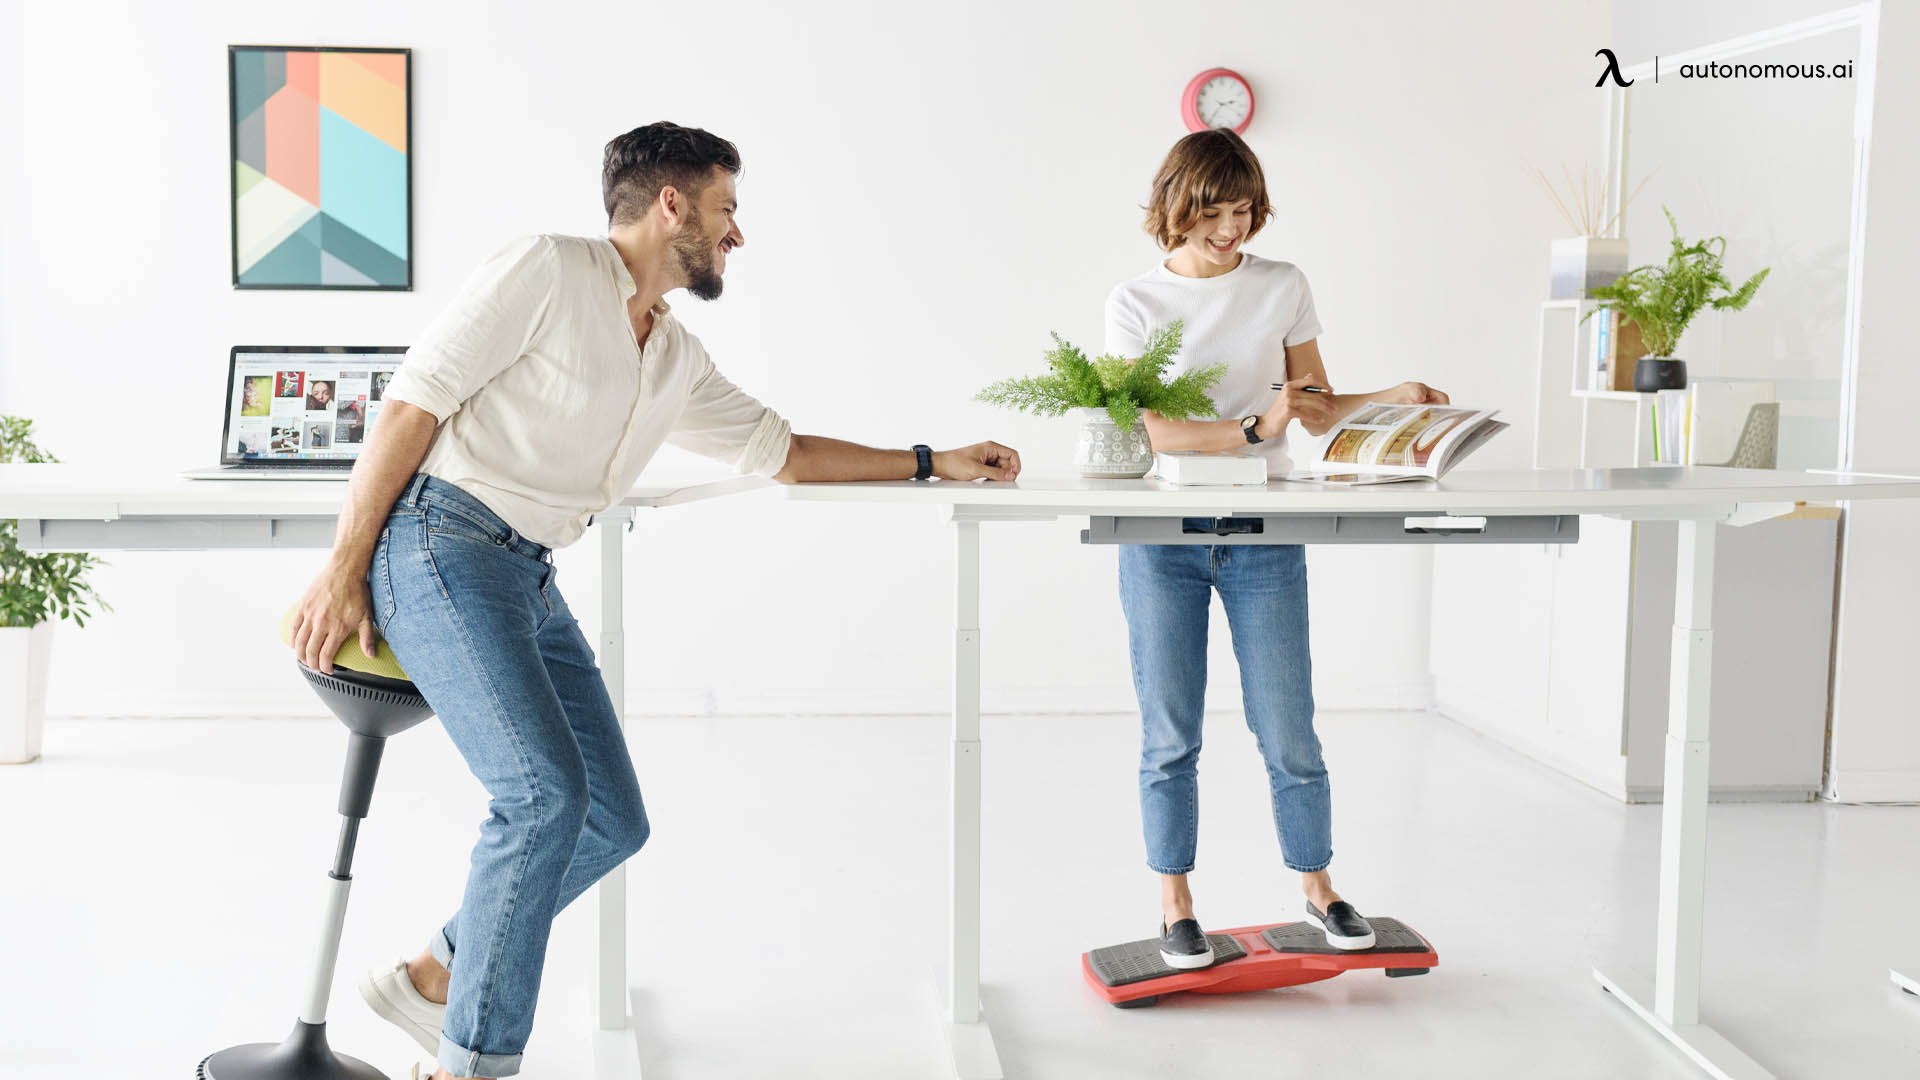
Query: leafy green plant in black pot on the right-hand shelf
1588 206 1768 394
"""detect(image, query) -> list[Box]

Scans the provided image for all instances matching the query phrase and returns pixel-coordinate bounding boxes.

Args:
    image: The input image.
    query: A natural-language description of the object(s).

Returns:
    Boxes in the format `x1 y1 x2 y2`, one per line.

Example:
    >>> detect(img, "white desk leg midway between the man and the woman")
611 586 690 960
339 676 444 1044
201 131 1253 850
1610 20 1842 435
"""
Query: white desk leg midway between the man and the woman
939 521 1002 1080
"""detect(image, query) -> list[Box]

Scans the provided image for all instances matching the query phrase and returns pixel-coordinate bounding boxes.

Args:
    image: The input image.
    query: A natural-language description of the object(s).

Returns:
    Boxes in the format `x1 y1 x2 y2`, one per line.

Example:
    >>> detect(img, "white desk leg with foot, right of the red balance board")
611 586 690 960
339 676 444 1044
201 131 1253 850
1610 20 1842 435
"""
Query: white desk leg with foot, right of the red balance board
1594 521 1772 1080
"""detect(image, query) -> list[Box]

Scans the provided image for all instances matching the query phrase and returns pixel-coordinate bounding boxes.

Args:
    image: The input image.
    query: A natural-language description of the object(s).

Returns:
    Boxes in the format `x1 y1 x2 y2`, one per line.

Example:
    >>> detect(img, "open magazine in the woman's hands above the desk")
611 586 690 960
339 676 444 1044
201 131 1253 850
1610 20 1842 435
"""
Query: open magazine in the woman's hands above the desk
1286 404 1507 484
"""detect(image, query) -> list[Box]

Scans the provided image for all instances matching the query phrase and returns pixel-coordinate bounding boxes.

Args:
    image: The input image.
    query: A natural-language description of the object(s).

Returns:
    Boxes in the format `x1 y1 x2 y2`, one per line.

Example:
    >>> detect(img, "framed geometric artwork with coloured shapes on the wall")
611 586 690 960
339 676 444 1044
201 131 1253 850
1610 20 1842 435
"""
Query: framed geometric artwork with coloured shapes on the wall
227 44 413 290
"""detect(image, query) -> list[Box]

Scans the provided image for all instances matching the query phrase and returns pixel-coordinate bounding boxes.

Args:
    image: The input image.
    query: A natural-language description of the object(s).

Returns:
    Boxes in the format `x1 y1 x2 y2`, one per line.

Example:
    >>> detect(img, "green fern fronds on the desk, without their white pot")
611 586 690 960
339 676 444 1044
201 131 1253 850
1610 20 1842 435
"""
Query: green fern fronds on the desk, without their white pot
975 323 1227 430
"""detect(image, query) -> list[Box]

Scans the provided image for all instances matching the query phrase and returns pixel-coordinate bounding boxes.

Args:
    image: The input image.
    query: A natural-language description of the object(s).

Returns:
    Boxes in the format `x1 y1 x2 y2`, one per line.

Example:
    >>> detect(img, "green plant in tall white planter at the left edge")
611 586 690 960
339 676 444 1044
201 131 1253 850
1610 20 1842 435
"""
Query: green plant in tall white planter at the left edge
0 417 111 765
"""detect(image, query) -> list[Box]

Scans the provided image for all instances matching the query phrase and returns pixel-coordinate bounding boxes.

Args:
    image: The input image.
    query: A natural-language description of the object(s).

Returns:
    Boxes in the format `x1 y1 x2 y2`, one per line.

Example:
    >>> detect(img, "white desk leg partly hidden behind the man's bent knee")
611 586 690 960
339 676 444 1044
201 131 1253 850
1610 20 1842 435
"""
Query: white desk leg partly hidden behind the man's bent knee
593 505 639 1080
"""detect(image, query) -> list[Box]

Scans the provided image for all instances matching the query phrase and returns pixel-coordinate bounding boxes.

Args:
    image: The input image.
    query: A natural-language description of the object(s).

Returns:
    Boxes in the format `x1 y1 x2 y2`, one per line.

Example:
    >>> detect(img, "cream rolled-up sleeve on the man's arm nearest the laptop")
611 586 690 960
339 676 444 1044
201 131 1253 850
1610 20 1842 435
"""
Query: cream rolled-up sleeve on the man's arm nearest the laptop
384 236 559 423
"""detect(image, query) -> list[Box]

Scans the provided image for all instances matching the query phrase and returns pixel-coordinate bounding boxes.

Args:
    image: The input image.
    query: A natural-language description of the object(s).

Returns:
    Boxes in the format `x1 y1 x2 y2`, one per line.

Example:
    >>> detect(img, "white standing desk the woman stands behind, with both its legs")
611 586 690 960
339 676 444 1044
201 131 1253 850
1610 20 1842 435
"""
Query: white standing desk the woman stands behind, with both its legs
756 467 1920 1080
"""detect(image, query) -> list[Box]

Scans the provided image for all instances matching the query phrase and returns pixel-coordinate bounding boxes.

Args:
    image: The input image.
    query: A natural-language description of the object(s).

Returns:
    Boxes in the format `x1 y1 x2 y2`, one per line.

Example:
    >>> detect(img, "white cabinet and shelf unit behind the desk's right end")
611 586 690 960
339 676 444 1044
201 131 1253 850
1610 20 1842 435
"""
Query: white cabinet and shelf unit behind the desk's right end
1430 300 1839 801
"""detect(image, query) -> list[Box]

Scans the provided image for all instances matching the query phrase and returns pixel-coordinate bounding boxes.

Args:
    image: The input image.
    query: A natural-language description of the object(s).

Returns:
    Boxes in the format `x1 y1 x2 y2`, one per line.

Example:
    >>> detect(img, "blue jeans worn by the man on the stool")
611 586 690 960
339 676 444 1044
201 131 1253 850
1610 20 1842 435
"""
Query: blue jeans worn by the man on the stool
367 475 647 1076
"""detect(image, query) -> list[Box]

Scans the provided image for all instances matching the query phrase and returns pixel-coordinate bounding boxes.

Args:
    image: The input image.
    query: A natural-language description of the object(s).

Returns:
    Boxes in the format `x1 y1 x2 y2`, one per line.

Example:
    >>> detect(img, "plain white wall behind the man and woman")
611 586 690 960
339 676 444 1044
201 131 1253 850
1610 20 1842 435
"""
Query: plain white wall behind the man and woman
0 0 1607 715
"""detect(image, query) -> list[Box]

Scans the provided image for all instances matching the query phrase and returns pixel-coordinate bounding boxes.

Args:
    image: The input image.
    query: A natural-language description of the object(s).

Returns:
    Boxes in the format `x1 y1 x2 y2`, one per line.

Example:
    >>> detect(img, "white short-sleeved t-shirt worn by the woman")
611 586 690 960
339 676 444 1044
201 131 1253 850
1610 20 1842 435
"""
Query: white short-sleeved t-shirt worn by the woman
1106 252 1319 477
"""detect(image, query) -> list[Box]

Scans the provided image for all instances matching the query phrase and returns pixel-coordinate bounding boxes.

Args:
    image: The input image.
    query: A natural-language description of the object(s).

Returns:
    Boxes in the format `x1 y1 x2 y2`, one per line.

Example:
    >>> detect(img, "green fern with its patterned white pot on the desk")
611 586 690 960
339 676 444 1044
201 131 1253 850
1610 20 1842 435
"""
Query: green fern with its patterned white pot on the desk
977 323 1227 480
